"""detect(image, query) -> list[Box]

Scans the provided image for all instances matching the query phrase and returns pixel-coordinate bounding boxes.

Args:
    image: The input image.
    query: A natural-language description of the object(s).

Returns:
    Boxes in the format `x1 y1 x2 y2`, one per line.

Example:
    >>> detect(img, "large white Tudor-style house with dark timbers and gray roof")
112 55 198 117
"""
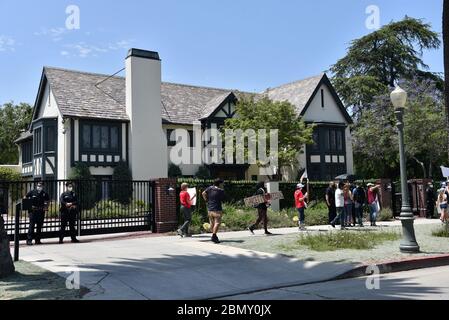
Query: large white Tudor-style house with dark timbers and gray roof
16 49 353 180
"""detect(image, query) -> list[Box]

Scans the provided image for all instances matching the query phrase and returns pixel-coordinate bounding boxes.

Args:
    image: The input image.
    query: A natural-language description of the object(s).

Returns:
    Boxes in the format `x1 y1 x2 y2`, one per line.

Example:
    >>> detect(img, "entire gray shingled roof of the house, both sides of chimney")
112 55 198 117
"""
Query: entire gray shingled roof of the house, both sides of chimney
40 67 323 124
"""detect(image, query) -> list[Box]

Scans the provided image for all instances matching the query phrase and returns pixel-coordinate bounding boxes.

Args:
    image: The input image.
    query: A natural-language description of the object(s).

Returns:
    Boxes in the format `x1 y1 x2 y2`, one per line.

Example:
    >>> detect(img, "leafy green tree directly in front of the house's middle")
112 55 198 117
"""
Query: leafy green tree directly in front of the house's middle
223 96 313 179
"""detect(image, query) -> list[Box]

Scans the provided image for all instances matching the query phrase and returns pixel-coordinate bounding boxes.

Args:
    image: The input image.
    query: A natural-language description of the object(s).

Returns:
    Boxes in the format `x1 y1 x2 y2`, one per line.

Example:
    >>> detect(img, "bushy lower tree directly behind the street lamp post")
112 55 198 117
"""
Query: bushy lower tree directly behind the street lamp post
353 80 448 178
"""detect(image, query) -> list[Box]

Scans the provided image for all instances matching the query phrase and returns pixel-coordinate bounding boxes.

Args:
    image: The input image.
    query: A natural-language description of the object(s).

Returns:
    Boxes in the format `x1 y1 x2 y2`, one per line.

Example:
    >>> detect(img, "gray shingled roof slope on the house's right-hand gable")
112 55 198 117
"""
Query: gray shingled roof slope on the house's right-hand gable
264 73 324 114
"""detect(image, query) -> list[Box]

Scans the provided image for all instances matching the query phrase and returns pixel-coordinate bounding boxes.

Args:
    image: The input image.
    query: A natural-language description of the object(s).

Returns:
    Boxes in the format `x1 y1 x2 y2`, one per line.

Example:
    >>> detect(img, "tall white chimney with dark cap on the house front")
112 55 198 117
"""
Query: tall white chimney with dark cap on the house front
126 49 168 180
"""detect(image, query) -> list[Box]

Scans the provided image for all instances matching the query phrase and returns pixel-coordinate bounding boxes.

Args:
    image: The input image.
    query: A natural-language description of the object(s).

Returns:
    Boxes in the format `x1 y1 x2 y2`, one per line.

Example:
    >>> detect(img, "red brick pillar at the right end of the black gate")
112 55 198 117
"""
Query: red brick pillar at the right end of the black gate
154 178 178 233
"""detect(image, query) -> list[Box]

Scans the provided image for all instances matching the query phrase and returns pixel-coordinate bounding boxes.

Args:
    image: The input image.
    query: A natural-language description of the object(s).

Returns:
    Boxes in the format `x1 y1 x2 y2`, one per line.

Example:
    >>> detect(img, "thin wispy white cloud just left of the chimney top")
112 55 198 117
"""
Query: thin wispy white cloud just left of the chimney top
61 40 133 58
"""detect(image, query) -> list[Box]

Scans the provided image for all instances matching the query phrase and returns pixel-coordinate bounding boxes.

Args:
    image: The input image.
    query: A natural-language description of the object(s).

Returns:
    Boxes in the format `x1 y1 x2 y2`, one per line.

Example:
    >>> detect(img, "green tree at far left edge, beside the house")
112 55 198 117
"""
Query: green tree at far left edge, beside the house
0 102 33 164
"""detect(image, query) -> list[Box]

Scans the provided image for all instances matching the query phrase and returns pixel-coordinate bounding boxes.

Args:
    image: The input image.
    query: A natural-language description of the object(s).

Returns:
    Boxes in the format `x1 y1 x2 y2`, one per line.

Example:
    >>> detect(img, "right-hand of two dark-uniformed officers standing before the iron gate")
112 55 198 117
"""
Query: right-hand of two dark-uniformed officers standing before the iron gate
59 182 79 243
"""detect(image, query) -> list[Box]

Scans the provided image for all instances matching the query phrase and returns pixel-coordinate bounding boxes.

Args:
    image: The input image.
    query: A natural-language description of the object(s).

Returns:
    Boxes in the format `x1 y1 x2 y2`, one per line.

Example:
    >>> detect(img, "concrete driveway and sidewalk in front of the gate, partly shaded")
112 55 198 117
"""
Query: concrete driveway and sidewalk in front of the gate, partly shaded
20 220 438 300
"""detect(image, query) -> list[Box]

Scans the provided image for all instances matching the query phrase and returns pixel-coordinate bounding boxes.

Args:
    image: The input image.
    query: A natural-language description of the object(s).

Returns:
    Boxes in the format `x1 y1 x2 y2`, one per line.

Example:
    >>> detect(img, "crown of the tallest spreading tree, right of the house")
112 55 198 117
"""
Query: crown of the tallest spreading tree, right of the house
331 17 442 120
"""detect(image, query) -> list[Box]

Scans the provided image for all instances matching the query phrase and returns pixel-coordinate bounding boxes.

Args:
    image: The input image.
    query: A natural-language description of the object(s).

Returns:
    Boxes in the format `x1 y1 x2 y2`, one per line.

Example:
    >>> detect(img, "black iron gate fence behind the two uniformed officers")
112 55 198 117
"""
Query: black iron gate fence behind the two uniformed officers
0 180 155 240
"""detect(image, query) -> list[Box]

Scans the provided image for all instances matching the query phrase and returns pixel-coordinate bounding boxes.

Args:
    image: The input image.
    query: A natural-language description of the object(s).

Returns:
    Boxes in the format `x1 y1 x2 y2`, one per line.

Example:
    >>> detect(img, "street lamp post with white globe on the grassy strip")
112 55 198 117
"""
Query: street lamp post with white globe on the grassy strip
391 86 419 253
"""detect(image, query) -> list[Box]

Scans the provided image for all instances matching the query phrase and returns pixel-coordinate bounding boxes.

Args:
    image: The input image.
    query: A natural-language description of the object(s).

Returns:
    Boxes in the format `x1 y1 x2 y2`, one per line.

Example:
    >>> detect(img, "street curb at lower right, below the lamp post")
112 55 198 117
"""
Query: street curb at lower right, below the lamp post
331 254 449 281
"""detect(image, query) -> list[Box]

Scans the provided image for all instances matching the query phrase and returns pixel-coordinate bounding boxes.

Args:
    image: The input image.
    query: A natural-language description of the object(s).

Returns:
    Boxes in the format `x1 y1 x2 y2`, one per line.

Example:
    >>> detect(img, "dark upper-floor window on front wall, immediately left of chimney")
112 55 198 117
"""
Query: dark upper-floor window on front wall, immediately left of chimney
80 123 120 152
